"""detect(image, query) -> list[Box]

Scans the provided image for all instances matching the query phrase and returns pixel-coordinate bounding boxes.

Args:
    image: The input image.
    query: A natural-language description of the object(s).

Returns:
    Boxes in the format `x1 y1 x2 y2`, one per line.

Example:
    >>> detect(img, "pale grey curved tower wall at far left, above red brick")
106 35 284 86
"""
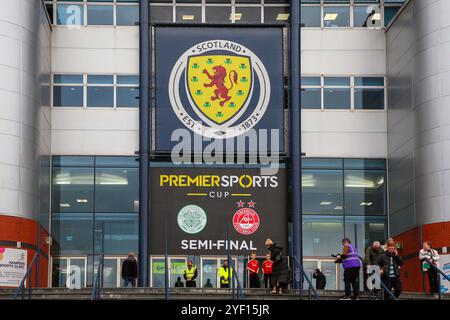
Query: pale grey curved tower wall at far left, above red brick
0 0 51 219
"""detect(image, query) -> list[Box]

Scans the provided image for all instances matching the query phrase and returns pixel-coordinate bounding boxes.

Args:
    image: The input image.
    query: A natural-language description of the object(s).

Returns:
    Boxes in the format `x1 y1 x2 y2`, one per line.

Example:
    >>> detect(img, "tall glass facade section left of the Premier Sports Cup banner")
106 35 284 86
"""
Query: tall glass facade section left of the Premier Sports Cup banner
51 156 139 256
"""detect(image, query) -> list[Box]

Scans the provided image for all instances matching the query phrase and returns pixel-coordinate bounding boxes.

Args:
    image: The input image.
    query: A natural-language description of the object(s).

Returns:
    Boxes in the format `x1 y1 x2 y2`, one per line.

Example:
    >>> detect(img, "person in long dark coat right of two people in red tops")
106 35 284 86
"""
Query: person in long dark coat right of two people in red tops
265 239 290 294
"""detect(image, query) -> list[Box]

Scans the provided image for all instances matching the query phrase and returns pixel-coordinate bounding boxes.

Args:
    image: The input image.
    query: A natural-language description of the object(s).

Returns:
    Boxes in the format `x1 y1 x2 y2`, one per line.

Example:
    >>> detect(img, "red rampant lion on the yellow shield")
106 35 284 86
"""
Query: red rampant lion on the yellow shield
203 65 238 107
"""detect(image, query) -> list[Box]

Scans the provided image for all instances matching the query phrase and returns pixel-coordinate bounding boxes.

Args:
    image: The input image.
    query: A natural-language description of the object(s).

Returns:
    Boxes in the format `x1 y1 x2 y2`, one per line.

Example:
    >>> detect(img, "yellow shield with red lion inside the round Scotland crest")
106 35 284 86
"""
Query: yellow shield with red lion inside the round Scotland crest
186 55 253 125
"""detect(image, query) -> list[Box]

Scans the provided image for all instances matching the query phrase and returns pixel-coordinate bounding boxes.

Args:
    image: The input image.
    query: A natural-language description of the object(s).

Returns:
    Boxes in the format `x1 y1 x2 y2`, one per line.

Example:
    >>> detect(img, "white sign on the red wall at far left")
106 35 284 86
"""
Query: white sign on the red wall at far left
0 248 27 287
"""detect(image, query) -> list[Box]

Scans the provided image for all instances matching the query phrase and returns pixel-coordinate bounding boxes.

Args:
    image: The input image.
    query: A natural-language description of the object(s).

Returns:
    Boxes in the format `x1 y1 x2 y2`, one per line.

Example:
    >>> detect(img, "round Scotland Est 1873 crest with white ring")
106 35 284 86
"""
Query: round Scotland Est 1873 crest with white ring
169 40 270 138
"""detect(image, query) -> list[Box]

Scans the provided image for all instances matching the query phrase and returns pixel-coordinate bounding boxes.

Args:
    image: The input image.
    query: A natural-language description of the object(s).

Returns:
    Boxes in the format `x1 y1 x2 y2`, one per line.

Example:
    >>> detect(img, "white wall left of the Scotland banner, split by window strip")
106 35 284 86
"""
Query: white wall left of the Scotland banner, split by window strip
52 26 139 155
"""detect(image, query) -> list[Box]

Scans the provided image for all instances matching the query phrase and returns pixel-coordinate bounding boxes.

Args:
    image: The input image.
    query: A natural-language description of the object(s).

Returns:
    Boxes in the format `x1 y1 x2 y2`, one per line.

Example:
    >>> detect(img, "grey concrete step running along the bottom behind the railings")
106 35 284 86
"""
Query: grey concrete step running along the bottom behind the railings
0 288 450 300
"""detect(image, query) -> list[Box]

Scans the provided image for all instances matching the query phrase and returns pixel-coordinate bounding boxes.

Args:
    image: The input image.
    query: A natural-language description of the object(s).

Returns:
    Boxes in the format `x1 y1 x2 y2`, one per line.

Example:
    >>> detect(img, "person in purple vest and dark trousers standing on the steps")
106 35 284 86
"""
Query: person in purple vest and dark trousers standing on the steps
336 238 362 300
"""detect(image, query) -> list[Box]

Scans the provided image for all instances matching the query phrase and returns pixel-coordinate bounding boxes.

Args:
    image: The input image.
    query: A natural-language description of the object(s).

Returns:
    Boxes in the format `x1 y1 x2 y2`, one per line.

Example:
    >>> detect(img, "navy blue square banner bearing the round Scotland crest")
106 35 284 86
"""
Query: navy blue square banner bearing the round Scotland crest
155 27 284 151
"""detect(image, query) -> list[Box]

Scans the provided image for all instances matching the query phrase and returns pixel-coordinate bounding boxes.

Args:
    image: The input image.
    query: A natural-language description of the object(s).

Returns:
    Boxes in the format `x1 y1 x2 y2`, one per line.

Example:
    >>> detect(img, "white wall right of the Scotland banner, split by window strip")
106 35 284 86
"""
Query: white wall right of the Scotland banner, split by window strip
302 28 387 158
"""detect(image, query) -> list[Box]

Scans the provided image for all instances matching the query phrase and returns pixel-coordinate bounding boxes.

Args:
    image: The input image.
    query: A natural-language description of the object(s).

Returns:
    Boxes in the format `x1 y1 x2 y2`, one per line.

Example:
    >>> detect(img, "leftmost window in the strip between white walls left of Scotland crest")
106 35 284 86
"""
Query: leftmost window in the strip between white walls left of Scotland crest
53 74 84 107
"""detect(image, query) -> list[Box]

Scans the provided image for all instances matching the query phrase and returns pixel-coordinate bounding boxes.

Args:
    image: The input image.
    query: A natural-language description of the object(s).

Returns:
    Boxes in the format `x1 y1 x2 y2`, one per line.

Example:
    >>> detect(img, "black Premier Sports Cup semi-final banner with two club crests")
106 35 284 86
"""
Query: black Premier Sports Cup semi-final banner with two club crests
150 168 288 255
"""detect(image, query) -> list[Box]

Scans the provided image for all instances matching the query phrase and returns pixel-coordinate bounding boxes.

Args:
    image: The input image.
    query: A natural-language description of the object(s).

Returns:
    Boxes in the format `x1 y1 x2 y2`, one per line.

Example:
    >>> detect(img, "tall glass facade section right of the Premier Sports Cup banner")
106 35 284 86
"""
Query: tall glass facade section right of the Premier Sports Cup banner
302 159 387 258
